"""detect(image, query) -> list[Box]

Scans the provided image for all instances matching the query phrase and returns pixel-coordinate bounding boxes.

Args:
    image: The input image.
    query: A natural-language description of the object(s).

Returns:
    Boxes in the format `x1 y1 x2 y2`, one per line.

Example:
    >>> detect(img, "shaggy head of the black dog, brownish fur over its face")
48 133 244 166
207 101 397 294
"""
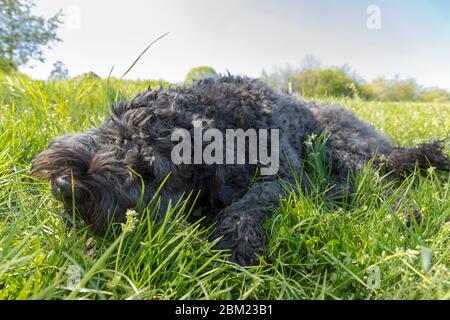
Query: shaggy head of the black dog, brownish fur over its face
31 133 141 233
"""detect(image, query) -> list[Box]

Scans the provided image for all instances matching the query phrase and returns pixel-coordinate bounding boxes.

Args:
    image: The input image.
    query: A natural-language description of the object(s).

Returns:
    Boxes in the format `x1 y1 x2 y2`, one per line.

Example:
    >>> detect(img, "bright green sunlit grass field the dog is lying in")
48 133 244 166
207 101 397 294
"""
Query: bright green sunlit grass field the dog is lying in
0 76 450 299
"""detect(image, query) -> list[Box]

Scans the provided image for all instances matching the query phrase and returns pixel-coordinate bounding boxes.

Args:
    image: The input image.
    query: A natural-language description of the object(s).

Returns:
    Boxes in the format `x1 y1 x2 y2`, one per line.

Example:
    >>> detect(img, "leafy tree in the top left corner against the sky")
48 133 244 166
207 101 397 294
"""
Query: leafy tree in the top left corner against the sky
0 0 62 67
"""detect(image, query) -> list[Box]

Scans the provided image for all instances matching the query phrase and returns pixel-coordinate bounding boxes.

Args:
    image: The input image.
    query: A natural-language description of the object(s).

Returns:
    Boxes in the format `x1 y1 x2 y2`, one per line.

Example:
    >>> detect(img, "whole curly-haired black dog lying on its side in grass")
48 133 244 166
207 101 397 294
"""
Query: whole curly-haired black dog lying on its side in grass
32 77 450 265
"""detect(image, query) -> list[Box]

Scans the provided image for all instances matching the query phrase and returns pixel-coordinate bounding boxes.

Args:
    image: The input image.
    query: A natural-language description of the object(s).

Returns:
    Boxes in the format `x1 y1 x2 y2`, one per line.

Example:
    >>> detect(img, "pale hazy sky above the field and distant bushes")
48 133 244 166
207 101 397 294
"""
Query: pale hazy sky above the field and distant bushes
23 0 450 89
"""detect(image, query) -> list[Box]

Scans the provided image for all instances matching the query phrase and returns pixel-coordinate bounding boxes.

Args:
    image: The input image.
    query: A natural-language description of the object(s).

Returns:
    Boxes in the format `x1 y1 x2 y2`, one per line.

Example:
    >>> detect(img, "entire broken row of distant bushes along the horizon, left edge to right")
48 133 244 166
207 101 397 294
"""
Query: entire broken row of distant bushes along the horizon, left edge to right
0 58 450 102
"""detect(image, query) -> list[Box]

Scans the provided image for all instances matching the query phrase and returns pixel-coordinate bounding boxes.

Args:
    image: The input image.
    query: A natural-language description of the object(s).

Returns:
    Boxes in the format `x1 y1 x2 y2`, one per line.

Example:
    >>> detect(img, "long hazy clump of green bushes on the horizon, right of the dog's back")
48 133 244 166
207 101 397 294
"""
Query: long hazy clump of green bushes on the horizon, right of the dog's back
261 57 450 102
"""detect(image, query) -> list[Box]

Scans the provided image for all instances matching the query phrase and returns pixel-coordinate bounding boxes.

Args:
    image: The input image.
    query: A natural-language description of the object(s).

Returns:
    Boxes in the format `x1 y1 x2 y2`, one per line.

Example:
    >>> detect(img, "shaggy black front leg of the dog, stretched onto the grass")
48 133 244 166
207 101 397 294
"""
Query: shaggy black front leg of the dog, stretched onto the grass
215 181 282 266
